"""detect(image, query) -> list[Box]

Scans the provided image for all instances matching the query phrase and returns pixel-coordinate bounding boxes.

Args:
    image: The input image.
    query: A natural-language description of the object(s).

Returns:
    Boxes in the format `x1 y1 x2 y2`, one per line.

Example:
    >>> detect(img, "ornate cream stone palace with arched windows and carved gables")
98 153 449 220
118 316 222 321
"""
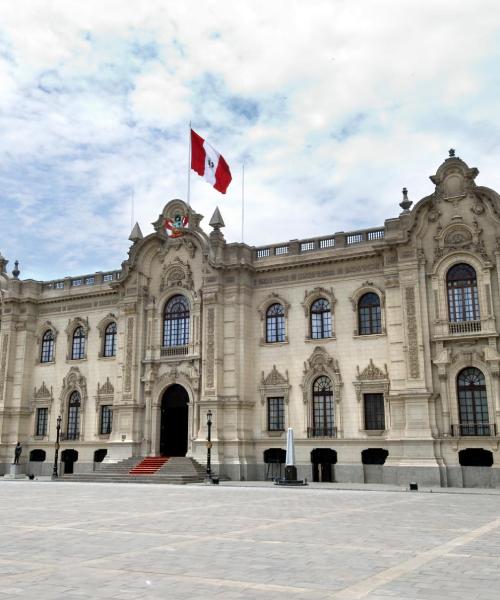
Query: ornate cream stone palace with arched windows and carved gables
0 150 500 487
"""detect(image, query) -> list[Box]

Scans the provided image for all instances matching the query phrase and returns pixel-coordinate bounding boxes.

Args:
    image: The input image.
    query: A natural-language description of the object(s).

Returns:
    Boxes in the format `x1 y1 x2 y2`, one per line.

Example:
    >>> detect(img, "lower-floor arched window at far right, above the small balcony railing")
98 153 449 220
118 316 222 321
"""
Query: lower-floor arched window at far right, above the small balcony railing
457 367 494 435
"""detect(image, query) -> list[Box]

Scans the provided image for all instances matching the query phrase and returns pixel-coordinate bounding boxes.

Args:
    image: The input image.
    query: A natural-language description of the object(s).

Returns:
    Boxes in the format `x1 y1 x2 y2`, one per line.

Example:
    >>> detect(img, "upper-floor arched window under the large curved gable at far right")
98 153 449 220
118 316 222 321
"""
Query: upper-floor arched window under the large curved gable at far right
446 263 480 323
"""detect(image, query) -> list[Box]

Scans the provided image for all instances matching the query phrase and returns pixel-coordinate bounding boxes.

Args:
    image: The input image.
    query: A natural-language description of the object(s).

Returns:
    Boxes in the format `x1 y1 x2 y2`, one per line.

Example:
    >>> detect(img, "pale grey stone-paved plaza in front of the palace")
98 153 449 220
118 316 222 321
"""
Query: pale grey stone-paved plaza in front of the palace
0 481 500 600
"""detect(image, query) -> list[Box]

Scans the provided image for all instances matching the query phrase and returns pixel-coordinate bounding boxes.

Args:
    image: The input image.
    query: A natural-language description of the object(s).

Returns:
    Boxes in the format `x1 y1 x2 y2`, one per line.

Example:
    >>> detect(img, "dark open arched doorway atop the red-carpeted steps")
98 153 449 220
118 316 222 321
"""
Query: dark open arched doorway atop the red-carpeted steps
160 383 189 456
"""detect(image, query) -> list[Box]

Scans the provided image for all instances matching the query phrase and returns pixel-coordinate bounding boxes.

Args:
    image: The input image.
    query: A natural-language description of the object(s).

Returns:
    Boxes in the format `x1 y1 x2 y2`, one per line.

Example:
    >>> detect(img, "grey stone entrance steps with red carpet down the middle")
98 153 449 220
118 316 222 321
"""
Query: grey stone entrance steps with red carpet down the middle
59 456 205 484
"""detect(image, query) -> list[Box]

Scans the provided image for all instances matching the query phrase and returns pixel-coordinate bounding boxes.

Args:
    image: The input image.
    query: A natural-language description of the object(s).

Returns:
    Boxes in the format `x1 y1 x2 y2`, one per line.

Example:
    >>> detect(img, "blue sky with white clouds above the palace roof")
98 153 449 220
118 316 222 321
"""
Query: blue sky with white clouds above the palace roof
0 0 500 279
